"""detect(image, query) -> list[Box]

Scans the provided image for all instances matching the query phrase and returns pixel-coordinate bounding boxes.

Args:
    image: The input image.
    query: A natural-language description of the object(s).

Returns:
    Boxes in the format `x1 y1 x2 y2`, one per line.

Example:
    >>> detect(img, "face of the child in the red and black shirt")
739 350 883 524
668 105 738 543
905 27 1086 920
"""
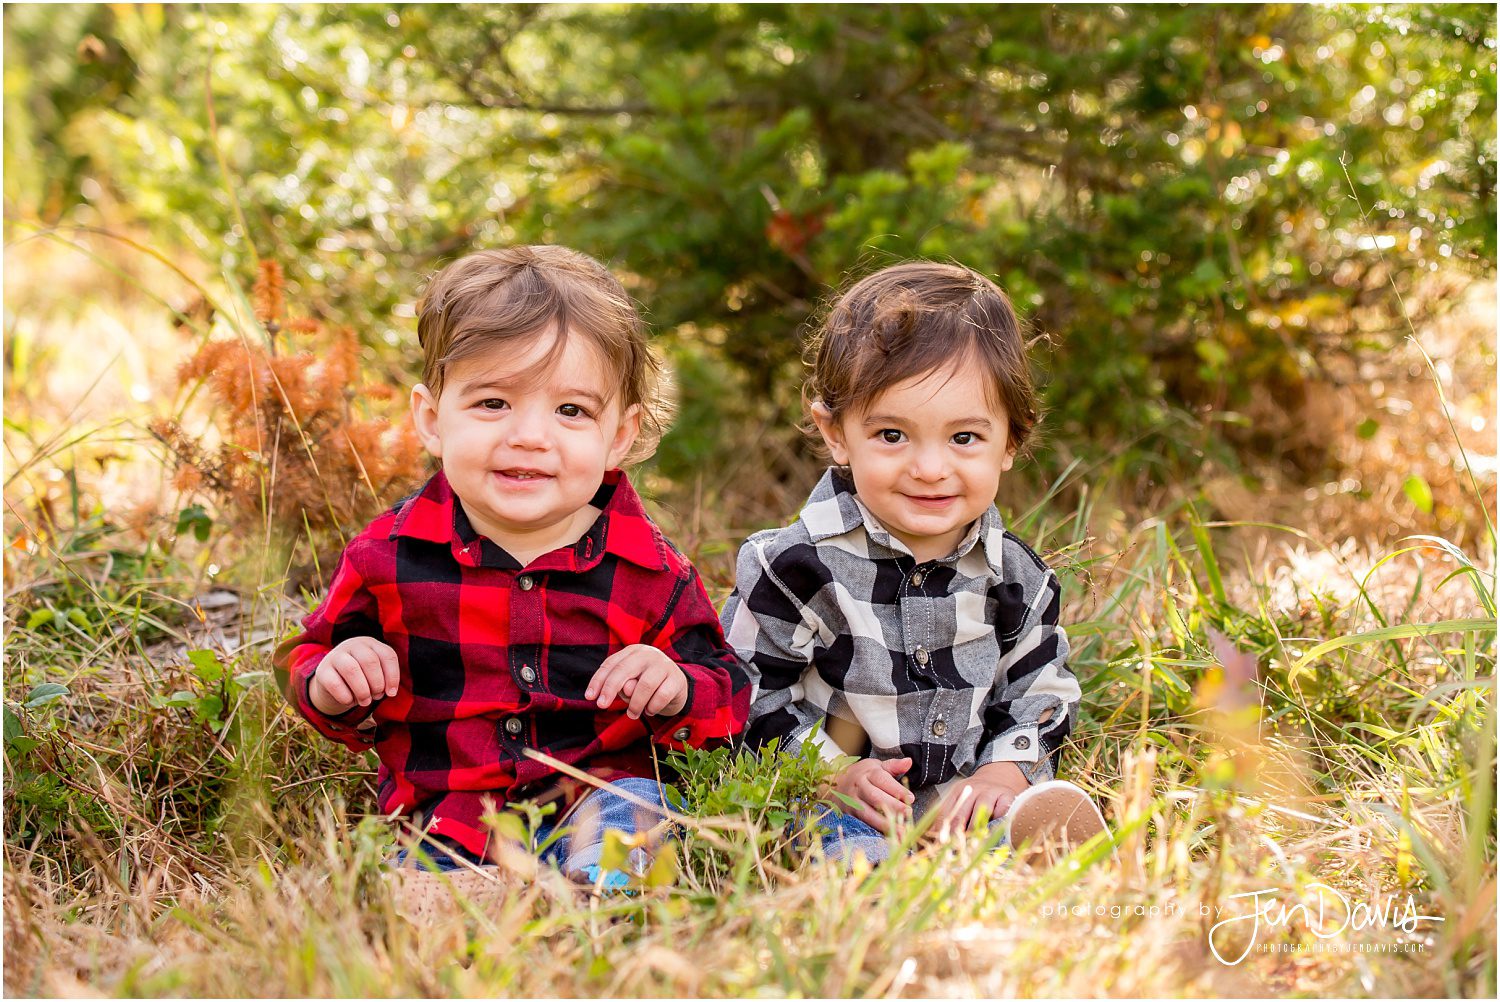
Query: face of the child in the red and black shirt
411 335 641 564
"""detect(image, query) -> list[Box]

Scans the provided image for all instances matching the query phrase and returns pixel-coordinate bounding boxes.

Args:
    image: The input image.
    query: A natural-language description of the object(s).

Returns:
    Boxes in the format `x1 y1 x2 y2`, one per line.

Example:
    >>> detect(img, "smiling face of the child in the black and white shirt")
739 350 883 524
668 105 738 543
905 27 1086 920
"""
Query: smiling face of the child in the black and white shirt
813 363 1014 561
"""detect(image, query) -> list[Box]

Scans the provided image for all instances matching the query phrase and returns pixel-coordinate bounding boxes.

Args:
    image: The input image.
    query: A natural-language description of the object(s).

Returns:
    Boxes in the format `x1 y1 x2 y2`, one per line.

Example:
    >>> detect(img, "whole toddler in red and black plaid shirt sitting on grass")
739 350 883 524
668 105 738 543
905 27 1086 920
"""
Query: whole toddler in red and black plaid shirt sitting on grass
276 246 750 884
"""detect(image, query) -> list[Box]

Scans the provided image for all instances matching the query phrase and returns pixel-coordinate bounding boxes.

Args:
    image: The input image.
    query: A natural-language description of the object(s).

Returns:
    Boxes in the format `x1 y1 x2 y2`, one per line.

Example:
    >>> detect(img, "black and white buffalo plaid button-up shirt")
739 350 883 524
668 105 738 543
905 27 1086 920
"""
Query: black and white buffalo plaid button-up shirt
723 468 1082 815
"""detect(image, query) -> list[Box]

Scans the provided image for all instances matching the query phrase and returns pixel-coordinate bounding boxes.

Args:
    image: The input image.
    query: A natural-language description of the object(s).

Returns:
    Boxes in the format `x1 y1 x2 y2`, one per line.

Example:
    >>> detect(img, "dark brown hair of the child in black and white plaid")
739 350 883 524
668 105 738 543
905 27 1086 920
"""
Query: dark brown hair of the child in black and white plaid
803 261 1041 450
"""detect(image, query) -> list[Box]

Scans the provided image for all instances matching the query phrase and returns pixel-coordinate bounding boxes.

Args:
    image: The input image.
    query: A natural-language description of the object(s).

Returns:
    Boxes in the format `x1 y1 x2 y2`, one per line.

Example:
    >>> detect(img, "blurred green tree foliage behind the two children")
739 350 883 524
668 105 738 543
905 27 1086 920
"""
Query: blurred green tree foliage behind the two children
5 5 1496 489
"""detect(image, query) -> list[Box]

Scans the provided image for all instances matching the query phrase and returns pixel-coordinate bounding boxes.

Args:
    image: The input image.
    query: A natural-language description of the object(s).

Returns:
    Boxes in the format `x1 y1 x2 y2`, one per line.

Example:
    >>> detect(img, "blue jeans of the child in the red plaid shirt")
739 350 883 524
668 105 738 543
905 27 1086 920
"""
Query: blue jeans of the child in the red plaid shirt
395 777 681 887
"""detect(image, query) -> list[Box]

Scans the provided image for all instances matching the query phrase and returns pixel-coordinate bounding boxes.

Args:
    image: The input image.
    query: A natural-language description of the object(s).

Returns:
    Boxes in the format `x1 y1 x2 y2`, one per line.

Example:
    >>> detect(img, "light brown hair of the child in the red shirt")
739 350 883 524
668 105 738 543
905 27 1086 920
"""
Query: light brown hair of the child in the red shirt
417 245 671 464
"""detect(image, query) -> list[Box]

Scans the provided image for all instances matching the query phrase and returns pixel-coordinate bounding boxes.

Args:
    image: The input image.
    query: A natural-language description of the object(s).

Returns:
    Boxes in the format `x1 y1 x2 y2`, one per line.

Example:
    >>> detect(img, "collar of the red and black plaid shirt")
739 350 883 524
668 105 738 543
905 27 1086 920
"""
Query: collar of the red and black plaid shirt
390 470 666 570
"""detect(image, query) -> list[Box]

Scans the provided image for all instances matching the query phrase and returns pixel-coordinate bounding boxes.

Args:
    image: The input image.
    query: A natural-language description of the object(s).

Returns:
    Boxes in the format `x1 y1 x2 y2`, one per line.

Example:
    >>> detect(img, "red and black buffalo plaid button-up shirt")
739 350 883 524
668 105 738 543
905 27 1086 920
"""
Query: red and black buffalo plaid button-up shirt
275 470 750 854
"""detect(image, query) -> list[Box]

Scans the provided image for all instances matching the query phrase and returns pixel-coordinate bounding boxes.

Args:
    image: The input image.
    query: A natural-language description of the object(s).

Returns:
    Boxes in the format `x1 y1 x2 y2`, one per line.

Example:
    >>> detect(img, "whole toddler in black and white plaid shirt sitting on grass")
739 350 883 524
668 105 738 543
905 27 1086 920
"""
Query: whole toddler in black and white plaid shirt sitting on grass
723 261 1103 860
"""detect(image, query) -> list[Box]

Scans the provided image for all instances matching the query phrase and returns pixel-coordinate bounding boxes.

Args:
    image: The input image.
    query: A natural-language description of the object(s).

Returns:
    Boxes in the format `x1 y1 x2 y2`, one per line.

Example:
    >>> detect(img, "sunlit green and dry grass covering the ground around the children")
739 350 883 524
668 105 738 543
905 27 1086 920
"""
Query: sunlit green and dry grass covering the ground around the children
5 232 1496 996
